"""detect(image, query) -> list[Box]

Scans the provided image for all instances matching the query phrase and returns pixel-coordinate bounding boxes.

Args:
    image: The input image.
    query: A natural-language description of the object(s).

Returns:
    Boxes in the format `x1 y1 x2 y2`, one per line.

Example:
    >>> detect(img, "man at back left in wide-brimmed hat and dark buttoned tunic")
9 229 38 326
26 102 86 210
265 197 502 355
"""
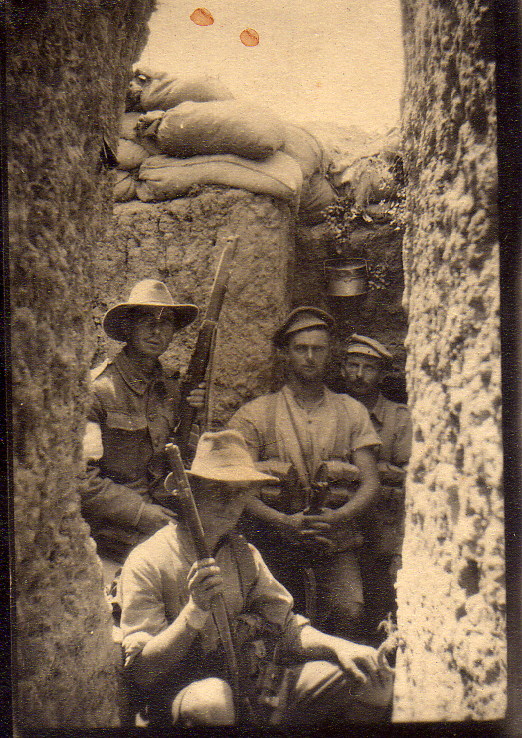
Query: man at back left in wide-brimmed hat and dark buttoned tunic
82 279 203 579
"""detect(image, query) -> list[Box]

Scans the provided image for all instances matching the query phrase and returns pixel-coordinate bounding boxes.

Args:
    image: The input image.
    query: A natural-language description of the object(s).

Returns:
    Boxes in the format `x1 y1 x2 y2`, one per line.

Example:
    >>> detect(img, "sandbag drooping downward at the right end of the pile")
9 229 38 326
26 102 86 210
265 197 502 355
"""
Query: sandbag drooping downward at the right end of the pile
281 123 336 225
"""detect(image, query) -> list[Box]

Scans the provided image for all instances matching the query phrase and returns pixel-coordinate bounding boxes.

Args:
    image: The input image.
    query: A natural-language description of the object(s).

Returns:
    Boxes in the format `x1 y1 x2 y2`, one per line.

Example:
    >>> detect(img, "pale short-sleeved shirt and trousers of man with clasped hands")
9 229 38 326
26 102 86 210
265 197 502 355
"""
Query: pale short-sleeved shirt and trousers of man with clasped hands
229 386 380 621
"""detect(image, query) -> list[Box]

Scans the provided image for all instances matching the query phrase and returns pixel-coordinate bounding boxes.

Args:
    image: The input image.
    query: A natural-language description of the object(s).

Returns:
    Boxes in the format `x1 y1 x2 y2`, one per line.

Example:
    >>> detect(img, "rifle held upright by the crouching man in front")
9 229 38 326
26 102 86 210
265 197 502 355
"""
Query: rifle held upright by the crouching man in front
161 443 253 721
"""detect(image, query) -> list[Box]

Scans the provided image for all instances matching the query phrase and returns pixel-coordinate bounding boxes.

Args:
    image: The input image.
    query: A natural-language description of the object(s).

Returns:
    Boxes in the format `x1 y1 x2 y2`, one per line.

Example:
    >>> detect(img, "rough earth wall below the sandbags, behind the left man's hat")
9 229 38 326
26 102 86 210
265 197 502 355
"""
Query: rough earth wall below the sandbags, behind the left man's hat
94 187 294 427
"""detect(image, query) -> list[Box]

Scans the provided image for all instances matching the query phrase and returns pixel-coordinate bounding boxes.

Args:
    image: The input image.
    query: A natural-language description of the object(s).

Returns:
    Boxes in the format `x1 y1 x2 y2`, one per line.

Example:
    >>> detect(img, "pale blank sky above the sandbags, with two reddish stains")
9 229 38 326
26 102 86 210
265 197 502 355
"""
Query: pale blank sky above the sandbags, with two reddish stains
140 0 403 132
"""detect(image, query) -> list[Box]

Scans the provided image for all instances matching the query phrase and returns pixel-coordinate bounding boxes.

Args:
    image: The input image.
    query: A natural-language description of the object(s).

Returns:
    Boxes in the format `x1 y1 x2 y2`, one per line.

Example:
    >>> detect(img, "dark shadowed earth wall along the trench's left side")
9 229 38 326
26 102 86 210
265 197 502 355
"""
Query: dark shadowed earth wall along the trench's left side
6 0 153 734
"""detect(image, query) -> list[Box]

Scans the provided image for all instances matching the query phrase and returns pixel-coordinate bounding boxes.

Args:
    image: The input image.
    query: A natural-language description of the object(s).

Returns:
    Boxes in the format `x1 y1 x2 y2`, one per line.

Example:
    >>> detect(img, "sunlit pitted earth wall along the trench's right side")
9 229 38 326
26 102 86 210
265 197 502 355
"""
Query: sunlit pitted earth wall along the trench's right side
394 0 506 721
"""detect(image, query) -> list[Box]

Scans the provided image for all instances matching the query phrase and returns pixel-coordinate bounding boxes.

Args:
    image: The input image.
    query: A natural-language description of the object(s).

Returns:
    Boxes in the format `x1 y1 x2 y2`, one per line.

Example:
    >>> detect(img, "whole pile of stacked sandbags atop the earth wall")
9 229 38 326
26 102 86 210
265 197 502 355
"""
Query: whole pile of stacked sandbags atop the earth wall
114 68 335 222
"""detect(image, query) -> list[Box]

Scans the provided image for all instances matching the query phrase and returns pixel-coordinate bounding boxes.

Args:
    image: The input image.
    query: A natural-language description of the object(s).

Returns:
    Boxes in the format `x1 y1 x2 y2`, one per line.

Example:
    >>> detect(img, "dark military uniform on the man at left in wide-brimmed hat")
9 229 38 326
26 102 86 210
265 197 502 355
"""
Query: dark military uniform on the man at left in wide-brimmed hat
82 350 180 562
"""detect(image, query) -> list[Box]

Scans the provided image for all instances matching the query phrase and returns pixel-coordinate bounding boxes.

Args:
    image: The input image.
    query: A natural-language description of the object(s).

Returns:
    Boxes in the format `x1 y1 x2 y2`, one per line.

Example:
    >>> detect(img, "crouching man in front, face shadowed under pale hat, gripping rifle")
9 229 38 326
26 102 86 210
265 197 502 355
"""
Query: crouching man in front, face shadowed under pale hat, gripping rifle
119 430 392 725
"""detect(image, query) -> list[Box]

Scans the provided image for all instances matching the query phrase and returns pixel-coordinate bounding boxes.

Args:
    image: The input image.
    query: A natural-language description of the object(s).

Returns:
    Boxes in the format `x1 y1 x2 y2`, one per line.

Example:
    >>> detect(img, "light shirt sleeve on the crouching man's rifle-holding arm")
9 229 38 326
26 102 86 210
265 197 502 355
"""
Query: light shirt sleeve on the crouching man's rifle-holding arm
118 552 168 666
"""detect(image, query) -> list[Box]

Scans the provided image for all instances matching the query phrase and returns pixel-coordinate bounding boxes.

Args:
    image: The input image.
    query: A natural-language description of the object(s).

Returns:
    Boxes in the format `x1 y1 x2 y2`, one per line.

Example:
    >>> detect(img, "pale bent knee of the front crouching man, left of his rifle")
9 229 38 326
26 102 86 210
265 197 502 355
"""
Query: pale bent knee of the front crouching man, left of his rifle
173 677 235 725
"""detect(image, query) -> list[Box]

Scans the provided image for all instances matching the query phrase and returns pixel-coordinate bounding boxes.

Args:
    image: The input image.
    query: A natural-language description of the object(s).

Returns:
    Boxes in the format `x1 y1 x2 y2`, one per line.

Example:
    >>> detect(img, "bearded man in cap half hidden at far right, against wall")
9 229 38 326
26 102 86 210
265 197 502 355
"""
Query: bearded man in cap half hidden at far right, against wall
341 333 412 632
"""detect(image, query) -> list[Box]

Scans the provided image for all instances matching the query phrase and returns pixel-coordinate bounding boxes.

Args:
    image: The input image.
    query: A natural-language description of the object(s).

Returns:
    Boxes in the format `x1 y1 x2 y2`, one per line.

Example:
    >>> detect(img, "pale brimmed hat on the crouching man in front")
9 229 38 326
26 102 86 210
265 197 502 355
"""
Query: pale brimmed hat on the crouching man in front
187 430 278 482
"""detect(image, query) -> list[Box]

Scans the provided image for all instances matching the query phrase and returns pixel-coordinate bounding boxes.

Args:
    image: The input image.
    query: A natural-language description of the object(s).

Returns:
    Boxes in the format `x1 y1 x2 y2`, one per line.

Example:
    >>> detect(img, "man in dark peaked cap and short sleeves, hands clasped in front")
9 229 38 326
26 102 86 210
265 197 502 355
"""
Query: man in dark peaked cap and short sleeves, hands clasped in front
225 306 380 636
